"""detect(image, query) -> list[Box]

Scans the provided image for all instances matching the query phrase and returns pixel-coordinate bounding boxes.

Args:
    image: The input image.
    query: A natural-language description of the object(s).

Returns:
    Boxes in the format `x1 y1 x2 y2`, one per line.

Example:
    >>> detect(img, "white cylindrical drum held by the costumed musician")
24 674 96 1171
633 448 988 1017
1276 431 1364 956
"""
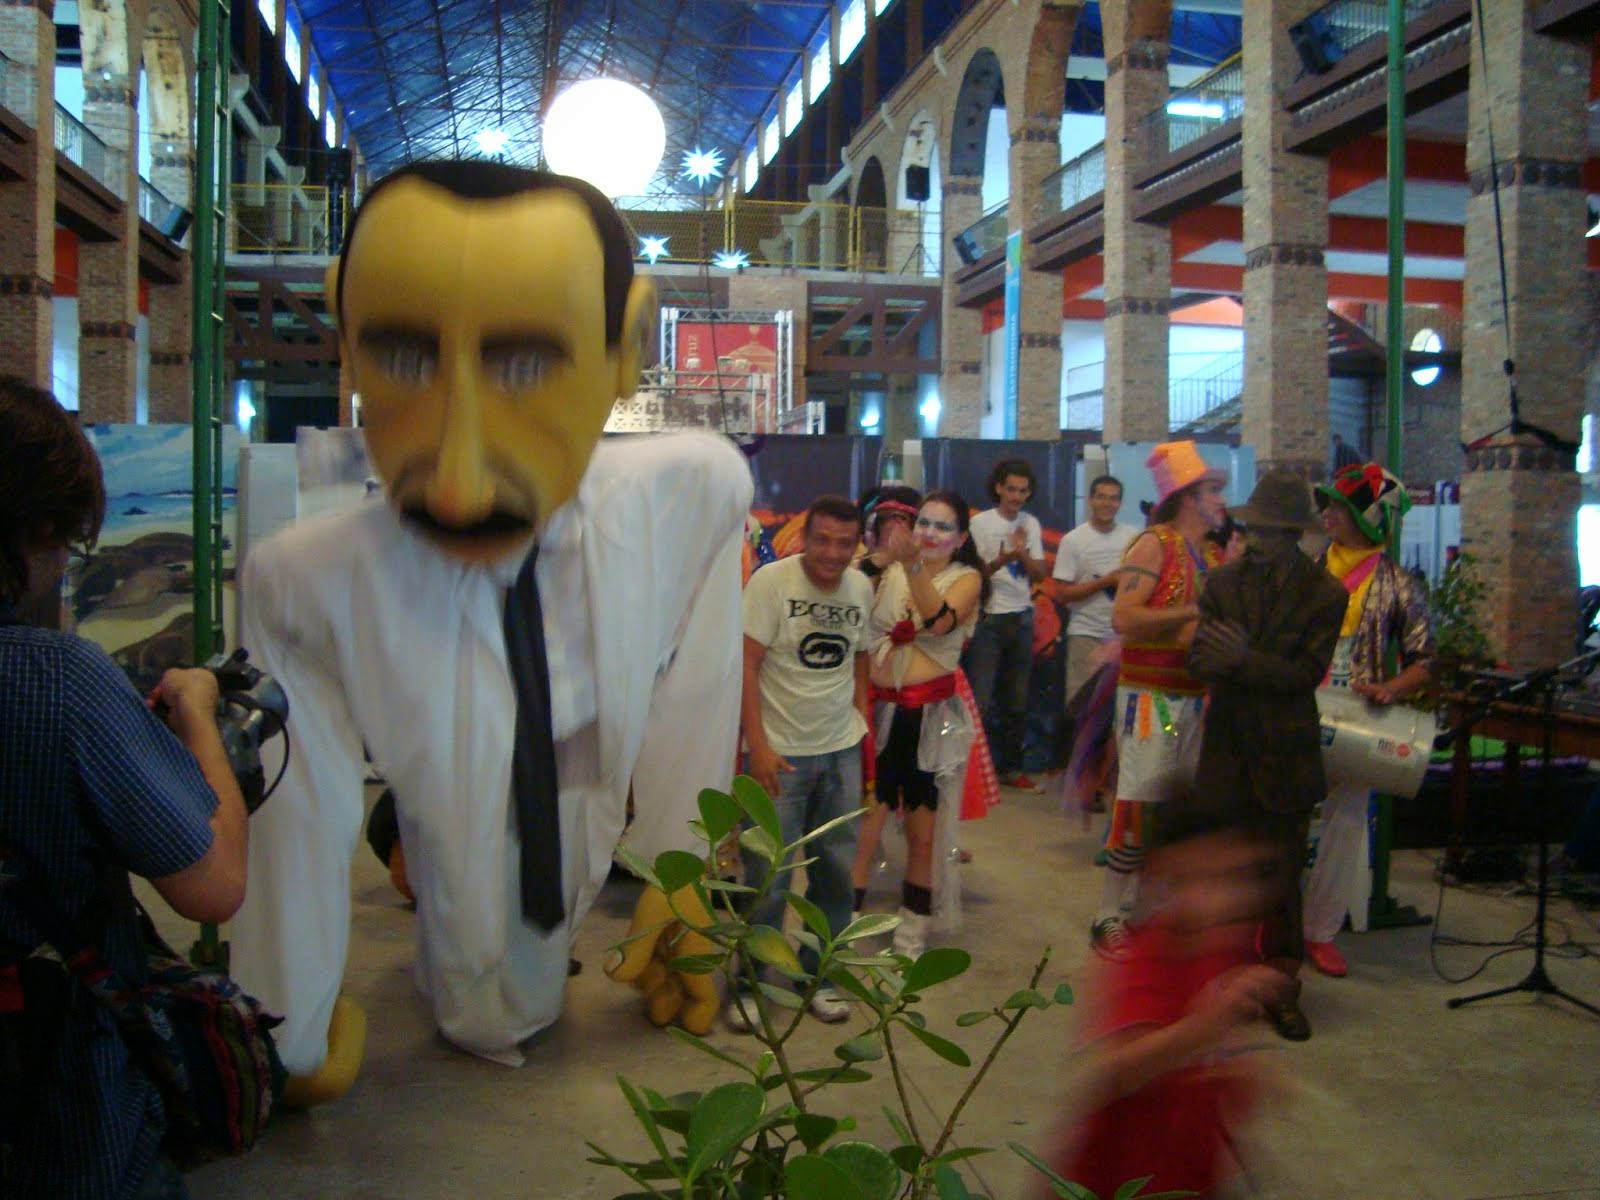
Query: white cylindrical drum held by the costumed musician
1317 688 1437 800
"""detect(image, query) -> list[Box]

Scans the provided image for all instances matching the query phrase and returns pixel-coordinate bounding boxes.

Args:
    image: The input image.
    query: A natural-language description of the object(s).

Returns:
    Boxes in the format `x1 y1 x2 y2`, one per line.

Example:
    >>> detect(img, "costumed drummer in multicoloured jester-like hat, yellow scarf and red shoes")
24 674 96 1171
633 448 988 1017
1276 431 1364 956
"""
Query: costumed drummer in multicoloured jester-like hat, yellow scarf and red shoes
1306 462 1434 976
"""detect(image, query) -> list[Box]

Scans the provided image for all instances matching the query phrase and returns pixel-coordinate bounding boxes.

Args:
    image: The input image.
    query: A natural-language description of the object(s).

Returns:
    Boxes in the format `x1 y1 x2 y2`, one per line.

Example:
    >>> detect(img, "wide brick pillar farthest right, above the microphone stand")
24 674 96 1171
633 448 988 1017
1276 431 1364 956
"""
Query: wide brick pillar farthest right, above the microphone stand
1461 5 1590 669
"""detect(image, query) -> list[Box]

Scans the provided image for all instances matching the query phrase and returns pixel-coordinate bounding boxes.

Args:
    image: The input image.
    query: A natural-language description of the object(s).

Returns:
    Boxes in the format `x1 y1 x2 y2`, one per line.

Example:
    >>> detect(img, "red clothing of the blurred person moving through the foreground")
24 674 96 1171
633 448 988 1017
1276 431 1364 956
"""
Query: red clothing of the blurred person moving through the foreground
1056 926 1256 1197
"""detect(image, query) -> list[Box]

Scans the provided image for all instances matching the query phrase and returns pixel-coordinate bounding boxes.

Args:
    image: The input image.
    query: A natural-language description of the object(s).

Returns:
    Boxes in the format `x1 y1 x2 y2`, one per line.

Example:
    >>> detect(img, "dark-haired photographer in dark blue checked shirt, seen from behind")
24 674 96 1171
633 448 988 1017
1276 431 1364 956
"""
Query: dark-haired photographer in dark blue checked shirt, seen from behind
0 379 246 1198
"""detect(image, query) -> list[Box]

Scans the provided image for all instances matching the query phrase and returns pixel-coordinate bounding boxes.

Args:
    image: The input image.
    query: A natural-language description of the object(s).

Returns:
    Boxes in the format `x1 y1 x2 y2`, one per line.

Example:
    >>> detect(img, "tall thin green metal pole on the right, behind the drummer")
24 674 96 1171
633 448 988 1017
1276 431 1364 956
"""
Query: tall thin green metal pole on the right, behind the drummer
1366 0 1429 930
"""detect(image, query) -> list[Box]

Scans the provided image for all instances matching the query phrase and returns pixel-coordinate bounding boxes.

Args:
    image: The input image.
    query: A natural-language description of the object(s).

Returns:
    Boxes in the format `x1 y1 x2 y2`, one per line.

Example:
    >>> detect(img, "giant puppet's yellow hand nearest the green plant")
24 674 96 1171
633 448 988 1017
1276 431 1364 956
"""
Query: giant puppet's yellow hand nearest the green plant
606 888 718 1034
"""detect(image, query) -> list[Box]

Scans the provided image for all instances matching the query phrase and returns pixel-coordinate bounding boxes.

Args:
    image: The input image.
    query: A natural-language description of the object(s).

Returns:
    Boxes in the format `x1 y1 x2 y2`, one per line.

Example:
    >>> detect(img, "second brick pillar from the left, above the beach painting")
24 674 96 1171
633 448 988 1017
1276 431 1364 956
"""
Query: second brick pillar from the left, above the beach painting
78 78 139 421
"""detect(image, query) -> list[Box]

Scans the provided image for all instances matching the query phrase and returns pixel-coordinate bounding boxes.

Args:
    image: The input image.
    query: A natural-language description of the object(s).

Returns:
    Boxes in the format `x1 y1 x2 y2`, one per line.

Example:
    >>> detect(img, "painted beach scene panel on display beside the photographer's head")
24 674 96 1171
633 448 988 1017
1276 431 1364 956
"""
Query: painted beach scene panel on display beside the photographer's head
67 426 238 691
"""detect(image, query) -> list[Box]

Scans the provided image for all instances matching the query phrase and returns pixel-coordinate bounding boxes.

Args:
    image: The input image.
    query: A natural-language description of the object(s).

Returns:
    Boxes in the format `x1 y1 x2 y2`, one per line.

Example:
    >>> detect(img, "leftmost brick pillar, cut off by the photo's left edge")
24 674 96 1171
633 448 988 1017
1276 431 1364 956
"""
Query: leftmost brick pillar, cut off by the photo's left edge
0 5 56 387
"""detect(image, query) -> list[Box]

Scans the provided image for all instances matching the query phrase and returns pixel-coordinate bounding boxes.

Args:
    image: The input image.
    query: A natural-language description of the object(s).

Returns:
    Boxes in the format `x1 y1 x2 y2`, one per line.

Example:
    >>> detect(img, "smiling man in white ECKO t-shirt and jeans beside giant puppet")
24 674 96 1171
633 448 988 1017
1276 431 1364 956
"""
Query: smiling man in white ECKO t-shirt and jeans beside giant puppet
725 496 872 1032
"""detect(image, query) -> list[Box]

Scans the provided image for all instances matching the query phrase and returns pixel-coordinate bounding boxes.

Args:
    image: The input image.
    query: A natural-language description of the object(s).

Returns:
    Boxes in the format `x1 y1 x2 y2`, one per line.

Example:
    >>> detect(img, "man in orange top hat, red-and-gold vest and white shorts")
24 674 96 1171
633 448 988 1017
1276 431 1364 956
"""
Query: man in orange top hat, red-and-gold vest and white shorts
1090 442 1227 957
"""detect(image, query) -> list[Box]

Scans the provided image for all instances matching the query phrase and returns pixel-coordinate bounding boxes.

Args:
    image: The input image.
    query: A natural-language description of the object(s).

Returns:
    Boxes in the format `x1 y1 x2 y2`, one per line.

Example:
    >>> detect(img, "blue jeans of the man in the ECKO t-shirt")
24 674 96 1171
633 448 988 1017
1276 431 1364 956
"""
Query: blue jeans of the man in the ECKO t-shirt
744 742 861 974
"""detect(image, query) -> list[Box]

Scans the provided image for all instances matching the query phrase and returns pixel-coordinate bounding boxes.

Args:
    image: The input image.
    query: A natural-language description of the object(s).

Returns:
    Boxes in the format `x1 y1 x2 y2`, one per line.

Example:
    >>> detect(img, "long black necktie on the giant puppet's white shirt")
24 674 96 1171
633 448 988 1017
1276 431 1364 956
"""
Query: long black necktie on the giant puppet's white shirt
506 546 565 930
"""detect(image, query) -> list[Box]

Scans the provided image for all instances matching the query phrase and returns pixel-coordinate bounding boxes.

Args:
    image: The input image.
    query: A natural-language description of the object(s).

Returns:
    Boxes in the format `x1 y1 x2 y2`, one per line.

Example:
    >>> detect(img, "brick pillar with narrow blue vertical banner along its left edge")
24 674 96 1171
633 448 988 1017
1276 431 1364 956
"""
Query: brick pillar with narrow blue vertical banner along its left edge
1000 115 1061 442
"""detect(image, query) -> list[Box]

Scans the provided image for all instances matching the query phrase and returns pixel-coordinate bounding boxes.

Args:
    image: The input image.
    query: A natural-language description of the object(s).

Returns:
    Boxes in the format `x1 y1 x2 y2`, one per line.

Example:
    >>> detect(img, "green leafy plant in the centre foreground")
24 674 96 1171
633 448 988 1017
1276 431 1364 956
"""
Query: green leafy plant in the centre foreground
589 776 1190 1200
